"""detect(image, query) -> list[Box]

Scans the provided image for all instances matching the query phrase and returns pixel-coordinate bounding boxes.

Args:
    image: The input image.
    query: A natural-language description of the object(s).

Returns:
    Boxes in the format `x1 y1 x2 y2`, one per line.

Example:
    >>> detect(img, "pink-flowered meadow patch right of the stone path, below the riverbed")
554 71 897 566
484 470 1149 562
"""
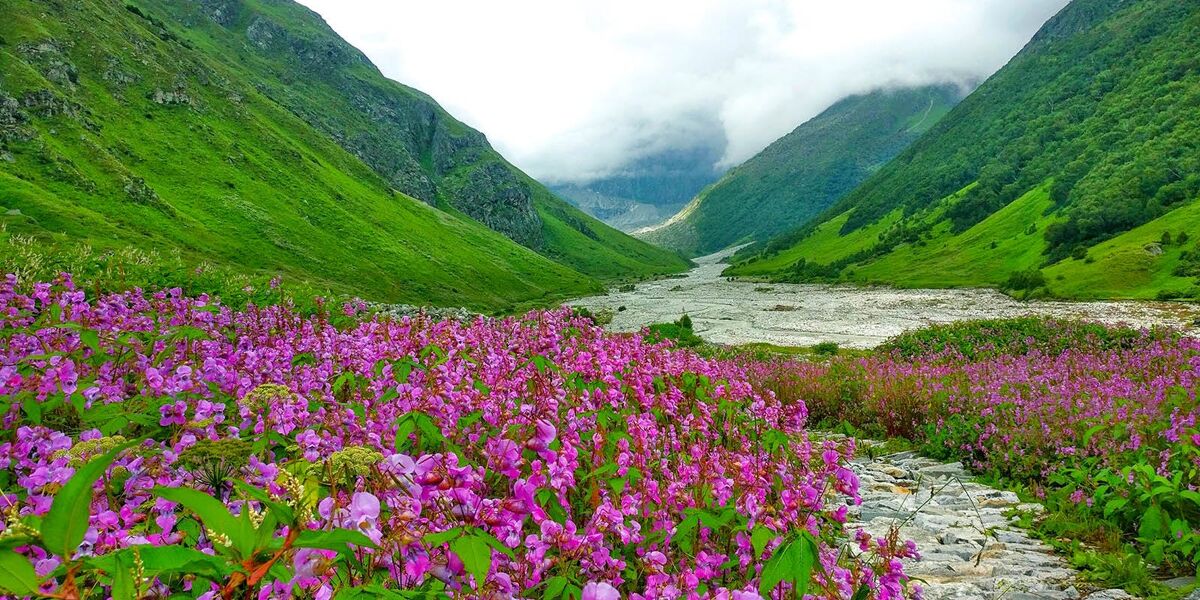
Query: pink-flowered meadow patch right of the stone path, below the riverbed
748 318 1200 598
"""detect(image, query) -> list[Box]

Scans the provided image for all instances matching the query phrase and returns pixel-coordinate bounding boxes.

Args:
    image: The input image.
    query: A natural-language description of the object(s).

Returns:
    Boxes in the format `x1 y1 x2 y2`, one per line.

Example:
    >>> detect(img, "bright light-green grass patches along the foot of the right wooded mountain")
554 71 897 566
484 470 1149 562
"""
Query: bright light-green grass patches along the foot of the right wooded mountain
726 175 1200 300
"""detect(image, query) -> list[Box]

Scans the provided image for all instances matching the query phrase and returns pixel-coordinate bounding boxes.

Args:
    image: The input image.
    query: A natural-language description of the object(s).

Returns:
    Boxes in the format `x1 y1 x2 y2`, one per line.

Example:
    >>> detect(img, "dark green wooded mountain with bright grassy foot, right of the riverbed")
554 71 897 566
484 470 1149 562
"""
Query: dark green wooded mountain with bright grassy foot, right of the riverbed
728 0 1200 298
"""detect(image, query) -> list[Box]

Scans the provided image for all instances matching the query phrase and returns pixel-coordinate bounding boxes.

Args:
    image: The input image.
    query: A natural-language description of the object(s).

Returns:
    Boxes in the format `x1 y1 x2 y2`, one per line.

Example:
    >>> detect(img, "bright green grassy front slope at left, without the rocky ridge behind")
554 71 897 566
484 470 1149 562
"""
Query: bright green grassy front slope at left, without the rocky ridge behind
0 0 598 308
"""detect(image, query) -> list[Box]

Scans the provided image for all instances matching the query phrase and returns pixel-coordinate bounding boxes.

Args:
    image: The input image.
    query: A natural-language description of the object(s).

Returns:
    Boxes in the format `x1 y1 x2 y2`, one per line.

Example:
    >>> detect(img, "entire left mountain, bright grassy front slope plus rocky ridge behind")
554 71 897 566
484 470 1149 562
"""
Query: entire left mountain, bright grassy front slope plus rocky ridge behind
0 0 686 307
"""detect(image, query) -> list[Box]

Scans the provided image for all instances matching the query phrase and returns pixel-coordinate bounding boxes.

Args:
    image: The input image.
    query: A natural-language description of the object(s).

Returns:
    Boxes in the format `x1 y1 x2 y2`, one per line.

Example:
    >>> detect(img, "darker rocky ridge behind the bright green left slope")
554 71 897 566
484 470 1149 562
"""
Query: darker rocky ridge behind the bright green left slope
137 0 686 278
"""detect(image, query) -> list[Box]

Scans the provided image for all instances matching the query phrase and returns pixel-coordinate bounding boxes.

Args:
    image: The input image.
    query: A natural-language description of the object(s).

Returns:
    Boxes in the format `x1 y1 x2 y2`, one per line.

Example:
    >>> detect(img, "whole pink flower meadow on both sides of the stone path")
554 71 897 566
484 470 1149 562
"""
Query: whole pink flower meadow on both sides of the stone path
0 275 1200 600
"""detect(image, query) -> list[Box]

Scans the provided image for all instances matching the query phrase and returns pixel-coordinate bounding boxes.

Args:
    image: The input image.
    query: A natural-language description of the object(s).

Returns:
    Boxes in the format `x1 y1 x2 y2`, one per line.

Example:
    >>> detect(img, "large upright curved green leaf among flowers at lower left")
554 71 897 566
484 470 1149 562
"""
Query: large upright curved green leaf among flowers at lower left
42 439 142 559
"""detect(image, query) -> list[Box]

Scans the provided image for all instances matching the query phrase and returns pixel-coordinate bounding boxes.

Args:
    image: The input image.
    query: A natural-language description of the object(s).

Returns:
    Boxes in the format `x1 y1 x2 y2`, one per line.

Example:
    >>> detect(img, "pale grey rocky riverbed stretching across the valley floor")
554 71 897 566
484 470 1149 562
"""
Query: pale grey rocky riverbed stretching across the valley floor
571 250 1200 348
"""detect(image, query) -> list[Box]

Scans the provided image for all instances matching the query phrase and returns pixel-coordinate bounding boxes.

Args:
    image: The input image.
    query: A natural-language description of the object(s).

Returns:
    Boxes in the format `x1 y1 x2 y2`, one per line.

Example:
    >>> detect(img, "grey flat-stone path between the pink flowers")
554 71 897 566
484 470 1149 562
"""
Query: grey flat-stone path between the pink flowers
846 452 1133 600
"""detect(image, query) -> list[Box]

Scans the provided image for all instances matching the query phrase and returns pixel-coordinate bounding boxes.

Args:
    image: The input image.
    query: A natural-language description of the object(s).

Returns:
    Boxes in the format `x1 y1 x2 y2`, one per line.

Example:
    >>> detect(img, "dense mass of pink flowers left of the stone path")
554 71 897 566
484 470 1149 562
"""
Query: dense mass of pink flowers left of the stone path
0 277 906 600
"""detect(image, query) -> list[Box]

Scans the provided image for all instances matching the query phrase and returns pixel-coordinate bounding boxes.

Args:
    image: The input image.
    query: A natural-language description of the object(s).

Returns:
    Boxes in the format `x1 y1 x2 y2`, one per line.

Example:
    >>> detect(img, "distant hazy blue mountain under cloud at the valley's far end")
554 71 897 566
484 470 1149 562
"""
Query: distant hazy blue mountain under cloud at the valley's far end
551 142 725 232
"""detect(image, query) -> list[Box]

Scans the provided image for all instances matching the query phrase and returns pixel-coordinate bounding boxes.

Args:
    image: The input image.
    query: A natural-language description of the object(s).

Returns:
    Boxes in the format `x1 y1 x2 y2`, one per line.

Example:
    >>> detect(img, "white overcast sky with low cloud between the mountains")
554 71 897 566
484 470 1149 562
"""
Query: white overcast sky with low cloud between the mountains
300 0 1067 181
